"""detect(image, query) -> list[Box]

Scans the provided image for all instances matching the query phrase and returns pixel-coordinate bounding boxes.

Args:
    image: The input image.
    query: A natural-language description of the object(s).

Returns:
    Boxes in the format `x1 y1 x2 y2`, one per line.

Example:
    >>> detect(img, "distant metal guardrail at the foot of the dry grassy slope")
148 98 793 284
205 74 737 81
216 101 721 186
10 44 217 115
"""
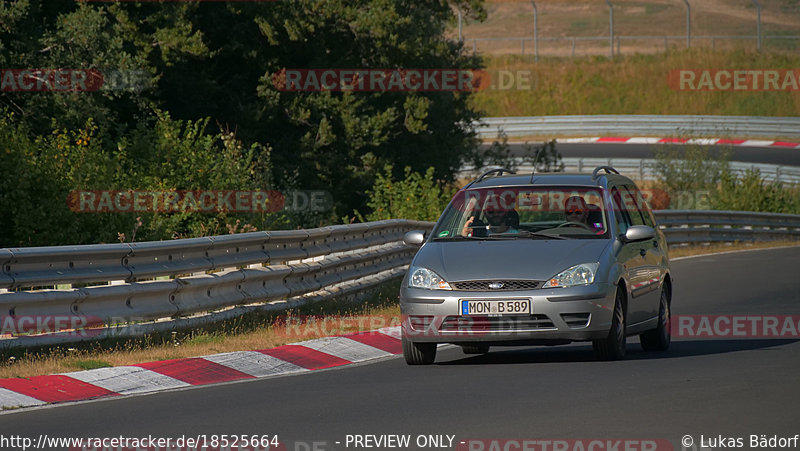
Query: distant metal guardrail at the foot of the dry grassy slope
475 115 800 139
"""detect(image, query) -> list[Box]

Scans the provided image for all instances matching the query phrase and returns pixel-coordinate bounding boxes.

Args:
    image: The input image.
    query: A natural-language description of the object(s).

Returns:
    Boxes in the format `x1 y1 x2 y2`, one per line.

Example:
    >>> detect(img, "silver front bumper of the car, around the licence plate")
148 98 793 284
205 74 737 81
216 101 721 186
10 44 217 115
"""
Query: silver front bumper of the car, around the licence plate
400 281 616 345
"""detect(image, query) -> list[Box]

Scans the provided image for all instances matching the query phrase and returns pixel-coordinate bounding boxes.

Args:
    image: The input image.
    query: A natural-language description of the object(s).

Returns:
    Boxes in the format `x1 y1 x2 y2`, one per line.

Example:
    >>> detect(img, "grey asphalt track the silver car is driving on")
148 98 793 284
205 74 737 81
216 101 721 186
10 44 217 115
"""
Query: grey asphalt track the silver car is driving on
0 247 800 450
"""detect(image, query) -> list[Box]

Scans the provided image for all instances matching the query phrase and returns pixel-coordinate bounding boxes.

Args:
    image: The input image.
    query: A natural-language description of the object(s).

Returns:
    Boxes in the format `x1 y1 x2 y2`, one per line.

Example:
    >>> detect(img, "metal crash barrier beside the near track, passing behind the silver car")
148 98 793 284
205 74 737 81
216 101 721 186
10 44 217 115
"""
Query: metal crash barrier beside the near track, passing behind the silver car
0 214 800 347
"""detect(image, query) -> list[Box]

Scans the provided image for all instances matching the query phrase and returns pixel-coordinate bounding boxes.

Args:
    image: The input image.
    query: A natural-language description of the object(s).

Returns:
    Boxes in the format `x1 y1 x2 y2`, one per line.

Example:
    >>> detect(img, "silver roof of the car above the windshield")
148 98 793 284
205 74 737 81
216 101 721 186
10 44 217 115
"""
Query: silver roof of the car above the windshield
466 172 633 189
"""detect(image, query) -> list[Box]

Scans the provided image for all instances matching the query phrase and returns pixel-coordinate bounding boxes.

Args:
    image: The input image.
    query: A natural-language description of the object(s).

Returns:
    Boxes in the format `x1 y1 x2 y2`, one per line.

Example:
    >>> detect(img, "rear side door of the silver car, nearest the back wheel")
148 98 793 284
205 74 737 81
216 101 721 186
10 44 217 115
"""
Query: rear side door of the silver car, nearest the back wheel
624 185 666 321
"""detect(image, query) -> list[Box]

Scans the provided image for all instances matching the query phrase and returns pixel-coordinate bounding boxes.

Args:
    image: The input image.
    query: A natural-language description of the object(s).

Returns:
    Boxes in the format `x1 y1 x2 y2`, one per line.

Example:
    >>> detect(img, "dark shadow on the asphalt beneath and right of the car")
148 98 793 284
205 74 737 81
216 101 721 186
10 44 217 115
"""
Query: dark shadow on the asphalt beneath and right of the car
437 338 800 365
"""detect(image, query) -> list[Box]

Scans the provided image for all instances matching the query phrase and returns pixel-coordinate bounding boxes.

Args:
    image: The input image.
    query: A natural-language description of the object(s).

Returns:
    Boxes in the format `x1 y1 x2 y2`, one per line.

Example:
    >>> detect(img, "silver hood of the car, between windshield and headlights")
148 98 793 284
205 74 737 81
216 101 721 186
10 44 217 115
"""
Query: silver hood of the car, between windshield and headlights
413 239 611 282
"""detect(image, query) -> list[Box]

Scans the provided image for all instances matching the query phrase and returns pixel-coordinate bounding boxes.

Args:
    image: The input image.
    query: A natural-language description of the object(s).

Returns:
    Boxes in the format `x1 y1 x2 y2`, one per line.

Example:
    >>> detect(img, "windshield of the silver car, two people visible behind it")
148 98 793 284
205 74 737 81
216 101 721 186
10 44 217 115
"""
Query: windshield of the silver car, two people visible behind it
433 186 608 241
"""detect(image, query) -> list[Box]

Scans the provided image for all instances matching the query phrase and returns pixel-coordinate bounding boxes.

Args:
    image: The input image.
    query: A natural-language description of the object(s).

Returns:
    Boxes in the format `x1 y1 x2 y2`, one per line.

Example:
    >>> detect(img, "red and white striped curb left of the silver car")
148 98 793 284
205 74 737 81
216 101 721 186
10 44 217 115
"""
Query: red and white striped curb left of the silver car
0 326 403 409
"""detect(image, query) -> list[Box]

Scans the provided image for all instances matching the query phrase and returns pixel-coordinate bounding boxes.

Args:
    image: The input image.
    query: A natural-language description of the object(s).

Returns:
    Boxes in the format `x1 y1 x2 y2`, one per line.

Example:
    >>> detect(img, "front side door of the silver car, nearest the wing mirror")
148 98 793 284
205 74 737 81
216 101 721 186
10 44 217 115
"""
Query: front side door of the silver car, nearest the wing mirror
611 185 650 324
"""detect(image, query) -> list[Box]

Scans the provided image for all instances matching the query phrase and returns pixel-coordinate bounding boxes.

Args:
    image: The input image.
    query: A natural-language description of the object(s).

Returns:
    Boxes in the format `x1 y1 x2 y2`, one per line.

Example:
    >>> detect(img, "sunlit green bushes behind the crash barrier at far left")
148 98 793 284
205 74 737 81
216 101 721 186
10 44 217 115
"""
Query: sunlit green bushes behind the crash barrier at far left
0 113 293 247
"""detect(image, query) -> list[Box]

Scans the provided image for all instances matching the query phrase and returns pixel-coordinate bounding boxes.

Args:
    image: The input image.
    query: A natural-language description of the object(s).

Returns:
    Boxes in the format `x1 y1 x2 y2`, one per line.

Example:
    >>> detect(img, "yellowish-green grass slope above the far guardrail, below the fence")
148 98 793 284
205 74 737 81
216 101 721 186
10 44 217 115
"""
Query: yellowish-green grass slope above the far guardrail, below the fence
472 49 800 118
